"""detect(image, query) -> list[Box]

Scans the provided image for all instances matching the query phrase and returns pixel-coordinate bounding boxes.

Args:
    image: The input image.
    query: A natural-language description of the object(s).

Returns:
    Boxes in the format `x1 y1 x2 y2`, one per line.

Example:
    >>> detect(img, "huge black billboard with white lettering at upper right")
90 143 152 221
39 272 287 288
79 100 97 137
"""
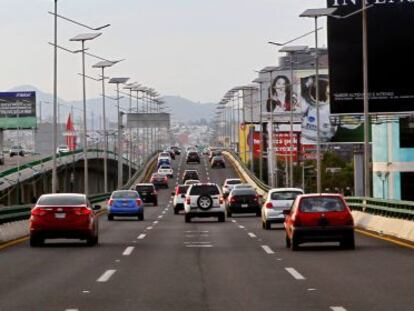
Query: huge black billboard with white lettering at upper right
327 0 414 114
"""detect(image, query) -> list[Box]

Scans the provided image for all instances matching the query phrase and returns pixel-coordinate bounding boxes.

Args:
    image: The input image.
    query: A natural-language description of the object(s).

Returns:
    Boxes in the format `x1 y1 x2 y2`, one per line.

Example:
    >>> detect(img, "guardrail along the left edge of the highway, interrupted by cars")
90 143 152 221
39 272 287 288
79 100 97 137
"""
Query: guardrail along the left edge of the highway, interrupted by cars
0 150 157 224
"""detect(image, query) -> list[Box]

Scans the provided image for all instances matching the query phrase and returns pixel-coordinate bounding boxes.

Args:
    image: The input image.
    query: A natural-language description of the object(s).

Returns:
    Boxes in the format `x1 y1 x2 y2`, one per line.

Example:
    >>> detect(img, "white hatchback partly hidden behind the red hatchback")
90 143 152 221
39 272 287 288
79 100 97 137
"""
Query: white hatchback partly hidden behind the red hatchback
262 188 303 230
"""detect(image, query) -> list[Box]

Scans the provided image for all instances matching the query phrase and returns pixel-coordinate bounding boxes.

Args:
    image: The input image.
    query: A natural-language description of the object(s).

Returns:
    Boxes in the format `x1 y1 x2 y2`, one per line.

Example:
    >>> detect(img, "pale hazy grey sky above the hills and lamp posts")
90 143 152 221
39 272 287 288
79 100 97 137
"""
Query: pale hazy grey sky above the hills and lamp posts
0 0 326 102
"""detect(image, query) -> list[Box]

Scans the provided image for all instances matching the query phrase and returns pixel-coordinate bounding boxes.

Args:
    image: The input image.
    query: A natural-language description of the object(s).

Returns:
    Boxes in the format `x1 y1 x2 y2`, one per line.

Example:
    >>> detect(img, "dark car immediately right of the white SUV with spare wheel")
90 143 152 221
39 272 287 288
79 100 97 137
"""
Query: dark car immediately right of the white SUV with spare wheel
227 189 261 217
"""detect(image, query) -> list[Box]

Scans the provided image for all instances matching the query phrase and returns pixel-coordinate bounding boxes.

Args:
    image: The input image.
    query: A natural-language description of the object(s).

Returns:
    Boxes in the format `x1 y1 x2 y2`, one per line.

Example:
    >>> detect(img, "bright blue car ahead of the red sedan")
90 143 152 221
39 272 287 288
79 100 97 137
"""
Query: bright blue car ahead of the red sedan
108 190 144 220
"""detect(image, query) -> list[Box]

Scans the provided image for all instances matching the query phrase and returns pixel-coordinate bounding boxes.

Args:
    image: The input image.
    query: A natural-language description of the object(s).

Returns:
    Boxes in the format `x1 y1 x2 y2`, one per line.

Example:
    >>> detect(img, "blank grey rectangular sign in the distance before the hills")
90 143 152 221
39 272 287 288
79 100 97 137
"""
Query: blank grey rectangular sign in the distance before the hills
126 112 170 128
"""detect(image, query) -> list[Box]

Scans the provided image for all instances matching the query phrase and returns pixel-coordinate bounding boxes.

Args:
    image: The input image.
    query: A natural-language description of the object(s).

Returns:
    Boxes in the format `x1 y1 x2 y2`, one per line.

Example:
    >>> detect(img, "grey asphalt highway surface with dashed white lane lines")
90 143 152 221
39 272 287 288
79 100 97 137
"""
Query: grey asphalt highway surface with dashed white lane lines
0 157 414 311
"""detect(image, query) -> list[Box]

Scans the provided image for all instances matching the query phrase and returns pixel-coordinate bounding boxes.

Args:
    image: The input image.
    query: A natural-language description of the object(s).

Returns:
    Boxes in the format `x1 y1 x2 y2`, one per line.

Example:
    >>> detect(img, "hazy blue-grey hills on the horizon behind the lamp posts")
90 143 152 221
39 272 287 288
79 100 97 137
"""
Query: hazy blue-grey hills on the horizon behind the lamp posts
9 85 215 125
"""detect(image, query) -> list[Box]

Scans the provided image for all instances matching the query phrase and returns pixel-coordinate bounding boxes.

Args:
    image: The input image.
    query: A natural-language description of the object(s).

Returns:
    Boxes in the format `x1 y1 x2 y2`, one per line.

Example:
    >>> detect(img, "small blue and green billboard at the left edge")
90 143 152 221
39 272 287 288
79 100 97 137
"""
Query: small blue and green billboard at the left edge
0 92 37 130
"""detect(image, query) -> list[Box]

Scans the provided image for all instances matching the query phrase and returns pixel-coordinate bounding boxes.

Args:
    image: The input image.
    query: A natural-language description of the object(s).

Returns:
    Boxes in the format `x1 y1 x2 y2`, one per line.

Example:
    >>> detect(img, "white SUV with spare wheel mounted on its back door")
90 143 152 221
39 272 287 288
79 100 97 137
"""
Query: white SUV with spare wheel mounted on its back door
184 183 226 222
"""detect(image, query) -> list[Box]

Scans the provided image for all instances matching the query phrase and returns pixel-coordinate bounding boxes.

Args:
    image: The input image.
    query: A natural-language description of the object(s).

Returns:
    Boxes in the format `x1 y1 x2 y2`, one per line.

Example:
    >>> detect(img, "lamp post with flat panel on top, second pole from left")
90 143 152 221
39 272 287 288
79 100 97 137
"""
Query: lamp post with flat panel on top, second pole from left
69 33 102 195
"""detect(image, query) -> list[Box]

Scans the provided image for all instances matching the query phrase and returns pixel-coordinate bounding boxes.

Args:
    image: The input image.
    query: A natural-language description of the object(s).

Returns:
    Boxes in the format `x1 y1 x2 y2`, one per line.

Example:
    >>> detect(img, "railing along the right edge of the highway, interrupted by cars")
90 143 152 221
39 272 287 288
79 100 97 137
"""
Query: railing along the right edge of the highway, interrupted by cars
225 150 414 221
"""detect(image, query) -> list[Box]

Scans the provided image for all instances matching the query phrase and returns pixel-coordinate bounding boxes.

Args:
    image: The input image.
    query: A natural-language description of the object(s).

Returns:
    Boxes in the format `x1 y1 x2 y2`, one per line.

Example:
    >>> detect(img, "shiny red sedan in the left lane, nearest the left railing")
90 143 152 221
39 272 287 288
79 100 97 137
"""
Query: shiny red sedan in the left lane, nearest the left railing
30 193 101 246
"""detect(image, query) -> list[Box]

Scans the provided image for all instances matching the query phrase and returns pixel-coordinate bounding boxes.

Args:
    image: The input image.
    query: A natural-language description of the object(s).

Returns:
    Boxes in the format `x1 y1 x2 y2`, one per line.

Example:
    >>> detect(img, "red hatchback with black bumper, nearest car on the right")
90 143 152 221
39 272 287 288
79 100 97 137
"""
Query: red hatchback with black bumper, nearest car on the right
284 194 355 250
